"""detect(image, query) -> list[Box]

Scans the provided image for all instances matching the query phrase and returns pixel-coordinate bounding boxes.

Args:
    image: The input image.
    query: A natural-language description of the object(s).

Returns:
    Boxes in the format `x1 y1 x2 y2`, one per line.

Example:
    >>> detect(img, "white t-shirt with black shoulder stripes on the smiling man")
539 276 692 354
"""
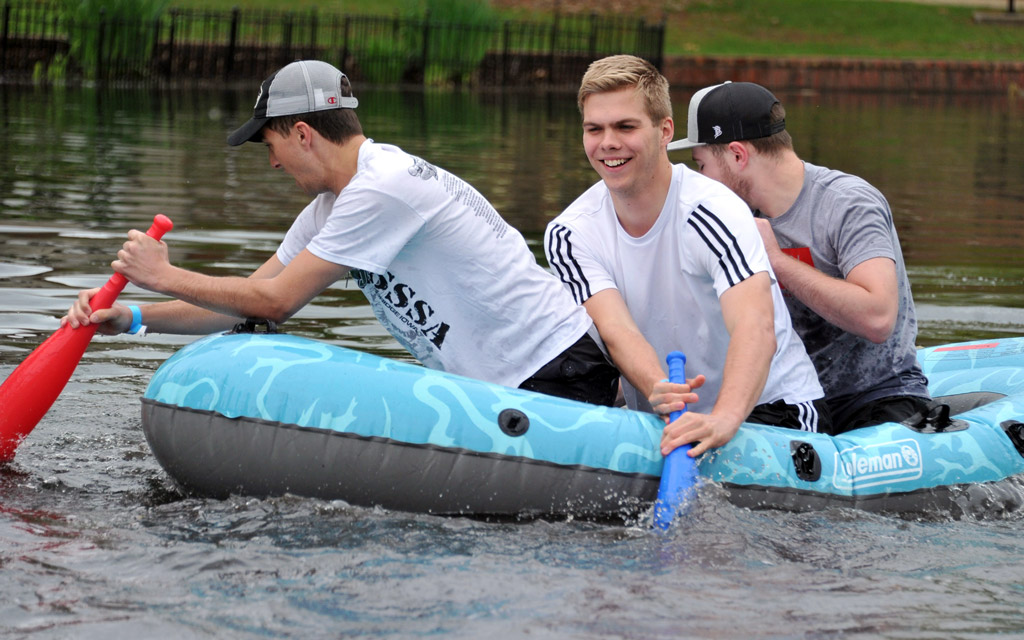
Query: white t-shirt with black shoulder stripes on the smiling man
545 165 823 413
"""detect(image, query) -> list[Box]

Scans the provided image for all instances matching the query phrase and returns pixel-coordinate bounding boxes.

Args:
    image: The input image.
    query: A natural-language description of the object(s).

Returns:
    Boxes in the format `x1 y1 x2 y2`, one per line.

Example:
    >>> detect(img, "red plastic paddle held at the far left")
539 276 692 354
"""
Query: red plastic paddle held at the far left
0 214 174 463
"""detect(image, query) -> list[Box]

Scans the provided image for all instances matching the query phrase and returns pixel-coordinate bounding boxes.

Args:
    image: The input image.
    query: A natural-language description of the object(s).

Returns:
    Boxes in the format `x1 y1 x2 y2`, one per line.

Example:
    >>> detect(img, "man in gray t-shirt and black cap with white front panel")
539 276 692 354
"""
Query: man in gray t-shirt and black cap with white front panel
669 82 931 433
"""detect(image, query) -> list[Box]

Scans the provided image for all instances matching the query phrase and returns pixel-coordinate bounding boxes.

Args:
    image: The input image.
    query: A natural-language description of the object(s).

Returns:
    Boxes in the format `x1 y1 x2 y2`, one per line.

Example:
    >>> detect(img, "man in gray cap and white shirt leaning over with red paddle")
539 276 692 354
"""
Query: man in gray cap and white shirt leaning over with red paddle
65 60 618 404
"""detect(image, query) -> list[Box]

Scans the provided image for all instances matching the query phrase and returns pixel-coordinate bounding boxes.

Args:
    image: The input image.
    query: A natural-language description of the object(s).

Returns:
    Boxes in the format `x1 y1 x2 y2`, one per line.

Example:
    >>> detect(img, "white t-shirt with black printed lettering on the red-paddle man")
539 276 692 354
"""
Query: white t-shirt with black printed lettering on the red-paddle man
278 140 592 387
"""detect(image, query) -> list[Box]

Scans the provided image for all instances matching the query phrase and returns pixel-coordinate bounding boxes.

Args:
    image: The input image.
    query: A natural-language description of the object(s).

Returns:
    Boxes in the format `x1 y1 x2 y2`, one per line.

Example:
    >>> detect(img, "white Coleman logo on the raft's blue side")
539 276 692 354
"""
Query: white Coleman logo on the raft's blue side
833 438 924 489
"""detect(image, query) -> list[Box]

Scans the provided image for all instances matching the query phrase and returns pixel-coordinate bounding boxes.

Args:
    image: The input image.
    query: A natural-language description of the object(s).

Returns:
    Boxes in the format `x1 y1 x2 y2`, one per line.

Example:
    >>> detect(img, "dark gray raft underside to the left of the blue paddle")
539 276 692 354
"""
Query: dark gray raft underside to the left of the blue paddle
142 398 659 519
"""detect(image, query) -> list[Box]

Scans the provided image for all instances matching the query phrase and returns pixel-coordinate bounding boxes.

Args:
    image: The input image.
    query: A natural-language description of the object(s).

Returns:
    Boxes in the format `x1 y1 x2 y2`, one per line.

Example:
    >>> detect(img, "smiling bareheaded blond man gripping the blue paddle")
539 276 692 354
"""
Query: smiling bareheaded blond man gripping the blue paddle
545 55 829 456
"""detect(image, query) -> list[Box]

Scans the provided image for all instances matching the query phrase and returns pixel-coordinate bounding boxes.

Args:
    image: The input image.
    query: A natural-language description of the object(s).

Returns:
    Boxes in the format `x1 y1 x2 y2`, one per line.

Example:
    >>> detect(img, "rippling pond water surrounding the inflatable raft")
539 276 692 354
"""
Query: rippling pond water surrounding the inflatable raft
0 86 1024 638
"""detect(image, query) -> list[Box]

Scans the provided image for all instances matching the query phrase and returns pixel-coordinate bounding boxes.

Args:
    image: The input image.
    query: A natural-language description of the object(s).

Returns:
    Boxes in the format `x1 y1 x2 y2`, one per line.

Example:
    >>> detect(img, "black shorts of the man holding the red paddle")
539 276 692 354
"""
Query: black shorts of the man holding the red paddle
519 334 618 407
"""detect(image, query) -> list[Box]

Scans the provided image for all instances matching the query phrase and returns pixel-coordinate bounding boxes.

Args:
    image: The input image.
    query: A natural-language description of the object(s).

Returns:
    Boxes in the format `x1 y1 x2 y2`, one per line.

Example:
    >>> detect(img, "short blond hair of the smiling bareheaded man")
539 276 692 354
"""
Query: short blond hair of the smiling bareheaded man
577 55 672 123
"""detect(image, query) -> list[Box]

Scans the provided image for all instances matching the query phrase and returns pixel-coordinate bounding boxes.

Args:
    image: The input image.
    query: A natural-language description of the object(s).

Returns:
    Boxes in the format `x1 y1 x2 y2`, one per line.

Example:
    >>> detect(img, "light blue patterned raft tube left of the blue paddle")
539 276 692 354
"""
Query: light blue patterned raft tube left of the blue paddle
144 334 664 477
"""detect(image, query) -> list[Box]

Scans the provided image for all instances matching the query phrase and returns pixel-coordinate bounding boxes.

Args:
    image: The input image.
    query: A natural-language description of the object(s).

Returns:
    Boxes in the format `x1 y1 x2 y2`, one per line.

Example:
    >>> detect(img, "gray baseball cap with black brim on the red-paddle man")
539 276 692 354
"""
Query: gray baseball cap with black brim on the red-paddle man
227 60 359 146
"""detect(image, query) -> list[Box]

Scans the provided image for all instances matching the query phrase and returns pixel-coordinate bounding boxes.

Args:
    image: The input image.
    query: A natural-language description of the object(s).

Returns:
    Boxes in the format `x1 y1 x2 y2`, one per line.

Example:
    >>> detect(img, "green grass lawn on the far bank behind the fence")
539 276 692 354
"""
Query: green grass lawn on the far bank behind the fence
171 0 1024 60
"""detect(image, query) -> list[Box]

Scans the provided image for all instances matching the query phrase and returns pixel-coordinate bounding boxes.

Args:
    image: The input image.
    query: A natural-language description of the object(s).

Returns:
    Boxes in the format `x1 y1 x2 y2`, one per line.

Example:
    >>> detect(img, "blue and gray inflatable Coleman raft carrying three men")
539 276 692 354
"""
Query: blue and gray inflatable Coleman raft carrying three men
142 333 1024 518
